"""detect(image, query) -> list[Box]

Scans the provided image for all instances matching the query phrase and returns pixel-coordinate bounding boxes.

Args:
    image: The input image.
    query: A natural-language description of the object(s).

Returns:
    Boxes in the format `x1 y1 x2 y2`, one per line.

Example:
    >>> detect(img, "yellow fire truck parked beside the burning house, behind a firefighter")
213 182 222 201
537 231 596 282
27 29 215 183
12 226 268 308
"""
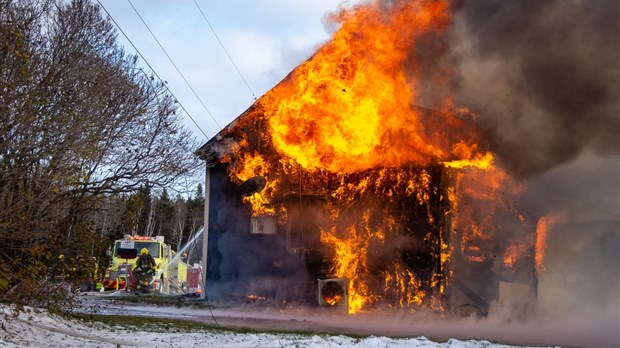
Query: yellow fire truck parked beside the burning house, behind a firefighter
102 235 194 293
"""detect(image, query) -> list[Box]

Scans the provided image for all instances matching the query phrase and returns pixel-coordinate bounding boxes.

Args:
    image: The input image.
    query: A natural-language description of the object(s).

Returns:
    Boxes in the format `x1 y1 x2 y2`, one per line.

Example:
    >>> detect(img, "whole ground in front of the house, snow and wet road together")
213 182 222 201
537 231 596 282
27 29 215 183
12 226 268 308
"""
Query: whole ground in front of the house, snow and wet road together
0 293 620 348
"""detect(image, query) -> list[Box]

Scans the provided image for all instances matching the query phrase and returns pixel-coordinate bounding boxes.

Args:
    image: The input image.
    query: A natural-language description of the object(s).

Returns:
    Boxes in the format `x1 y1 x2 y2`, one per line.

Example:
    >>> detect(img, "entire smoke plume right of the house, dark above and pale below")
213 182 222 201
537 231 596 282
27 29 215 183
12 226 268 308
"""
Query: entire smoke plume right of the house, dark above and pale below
443 0 620 346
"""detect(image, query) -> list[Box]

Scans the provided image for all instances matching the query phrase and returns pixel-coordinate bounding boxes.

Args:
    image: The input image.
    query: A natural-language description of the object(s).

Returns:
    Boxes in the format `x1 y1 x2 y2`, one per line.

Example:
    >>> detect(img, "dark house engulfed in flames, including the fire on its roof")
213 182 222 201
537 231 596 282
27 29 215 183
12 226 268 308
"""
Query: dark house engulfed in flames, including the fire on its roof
198 1 544 314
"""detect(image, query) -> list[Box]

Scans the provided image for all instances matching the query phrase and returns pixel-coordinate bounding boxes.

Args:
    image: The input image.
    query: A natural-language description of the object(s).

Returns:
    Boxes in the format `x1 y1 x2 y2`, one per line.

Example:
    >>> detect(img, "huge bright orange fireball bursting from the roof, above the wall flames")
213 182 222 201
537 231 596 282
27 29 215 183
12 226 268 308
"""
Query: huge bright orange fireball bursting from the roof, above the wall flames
263 1 490 173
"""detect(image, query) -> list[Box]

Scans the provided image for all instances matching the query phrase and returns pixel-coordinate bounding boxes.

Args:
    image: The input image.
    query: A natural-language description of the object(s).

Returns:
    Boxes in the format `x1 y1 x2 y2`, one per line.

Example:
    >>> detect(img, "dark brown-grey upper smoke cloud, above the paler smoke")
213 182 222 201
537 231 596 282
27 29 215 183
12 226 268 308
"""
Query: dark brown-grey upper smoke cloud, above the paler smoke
448 0 620 177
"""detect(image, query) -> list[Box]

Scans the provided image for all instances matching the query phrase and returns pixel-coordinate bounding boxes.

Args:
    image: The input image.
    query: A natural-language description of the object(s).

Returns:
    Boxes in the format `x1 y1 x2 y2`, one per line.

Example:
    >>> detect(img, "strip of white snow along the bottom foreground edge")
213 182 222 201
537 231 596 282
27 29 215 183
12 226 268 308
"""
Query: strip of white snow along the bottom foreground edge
0 305 524 348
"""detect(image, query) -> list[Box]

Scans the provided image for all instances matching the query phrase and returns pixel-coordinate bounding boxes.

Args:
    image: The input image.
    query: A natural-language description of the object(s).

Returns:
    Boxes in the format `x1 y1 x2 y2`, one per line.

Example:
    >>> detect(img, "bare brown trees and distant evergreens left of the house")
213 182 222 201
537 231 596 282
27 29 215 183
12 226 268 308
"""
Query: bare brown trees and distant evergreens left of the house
0 0 201 304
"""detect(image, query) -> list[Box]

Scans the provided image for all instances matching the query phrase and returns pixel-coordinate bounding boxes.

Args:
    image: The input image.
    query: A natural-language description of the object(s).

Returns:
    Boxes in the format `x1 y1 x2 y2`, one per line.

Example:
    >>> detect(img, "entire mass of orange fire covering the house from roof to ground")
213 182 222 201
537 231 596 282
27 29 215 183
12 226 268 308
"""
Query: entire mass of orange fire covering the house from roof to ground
217 0 543 313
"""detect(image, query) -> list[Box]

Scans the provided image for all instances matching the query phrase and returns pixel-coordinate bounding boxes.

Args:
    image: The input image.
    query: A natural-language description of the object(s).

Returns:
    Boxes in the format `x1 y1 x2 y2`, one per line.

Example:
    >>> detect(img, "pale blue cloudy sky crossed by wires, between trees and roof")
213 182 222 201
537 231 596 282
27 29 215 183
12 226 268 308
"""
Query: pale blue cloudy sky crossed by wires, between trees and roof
100 0 364 141
